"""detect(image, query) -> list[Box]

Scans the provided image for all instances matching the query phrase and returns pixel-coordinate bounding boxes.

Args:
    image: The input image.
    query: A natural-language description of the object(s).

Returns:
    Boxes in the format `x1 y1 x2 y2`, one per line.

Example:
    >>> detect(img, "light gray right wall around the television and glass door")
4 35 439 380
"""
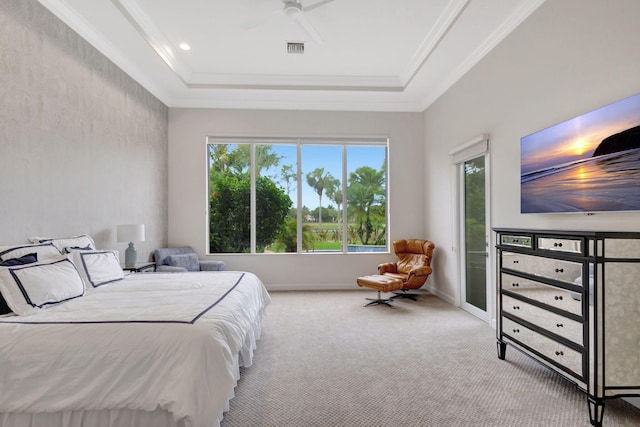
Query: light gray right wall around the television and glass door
424 0 640 310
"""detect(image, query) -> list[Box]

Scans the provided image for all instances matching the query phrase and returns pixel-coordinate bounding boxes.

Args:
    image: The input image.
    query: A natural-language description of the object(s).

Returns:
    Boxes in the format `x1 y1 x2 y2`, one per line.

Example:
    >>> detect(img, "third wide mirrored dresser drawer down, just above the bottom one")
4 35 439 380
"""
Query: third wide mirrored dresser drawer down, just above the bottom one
502 295 583 345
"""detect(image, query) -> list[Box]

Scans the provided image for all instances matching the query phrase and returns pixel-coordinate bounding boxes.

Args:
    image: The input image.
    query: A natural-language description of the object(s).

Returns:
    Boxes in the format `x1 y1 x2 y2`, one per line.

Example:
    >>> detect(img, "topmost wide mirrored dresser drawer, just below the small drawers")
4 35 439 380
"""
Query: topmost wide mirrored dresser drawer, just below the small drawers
502 252 582 285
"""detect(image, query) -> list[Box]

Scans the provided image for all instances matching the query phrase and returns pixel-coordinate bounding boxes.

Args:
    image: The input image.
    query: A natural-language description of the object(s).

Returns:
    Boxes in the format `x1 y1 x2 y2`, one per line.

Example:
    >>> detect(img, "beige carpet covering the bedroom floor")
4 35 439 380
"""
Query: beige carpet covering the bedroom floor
222 290 640 427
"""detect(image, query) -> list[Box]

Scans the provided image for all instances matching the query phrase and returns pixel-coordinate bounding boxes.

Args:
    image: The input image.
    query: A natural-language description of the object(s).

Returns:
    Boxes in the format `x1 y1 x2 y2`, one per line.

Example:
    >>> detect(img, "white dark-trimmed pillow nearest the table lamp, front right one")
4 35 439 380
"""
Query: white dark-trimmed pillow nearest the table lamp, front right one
69 249 124 290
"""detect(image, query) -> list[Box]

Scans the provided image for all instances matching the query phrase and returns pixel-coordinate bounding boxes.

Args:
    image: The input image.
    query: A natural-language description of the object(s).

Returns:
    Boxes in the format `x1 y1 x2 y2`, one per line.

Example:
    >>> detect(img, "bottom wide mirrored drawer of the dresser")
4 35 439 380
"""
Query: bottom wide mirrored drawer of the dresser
502 318 582 376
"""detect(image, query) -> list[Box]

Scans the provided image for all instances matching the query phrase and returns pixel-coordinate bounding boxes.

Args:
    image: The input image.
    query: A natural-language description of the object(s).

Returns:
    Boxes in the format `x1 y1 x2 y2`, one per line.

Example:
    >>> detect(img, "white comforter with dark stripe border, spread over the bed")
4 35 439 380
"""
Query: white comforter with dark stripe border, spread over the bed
0 272 270 427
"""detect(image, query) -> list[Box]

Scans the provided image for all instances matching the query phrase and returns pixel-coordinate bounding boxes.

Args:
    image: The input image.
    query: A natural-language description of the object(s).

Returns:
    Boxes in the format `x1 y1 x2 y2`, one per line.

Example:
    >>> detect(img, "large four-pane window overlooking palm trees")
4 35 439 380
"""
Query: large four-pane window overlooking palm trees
207 137 388 254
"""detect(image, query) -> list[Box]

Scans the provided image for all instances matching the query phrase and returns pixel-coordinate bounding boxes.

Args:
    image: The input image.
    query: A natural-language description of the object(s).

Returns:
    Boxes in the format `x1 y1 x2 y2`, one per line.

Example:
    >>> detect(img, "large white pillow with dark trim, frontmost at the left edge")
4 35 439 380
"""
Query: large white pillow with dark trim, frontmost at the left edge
0 257 84 316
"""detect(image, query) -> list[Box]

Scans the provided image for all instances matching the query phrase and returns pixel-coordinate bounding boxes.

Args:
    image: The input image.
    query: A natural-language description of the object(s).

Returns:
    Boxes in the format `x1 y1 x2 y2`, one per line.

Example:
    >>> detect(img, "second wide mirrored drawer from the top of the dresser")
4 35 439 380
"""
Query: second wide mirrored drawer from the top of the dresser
500 273 583 316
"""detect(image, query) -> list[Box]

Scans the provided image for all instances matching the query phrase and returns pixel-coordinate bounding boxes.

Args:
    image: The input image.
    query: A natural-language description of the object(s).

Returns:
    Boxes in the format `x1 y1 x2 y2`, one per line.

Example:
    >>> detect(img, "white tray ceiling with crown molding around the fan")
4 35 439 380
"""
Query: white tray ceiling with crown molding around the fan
39 0 545 112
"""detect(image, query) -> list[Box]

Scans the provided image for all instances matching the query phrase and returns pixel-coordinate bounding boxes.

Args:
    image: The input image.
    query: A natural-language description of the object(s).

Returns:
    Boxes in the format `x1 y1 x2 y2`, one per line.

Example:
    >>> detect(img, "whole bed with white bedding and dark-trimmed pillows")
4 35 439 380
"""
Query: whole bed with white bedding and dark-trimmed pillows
0 237 270 427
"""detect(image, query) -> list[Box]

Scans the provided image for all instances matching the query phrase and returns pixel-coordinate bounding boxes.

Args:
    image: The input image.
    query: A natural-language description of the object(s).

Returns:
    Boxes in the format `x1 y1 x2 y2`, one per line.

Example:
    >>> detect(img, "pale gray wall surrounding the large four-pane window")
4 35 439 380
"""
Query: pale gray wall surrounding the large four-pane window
169 108 425 289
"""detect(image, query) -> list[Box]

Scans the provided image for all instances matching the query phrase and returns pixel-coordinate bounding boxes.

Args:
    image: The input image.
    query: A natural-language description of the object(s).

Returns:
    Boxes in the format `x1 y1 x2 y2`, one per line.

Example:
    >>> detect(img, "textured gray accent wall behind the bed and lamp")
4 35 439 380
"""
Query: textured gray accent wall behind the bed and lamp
0 0 168 259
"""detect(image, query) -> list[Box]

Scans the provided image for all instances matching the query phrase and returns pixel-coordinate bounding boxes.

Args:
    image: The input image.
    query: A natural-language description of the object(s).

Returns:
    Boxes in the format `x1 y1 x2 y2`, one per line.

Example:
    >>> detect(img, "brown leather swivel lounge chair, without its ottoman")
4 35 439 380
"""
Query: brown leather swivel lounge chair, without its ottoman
378 239 436 301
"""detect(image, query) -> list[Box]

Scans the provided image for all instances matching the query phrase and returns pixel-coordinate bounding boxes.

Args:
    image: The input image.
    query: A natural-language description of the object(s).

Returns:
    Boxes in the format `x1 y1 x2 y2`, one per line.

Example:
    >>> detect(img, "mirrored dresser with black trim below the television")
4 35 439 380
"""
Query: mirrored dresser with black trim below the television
494 228 640 426
